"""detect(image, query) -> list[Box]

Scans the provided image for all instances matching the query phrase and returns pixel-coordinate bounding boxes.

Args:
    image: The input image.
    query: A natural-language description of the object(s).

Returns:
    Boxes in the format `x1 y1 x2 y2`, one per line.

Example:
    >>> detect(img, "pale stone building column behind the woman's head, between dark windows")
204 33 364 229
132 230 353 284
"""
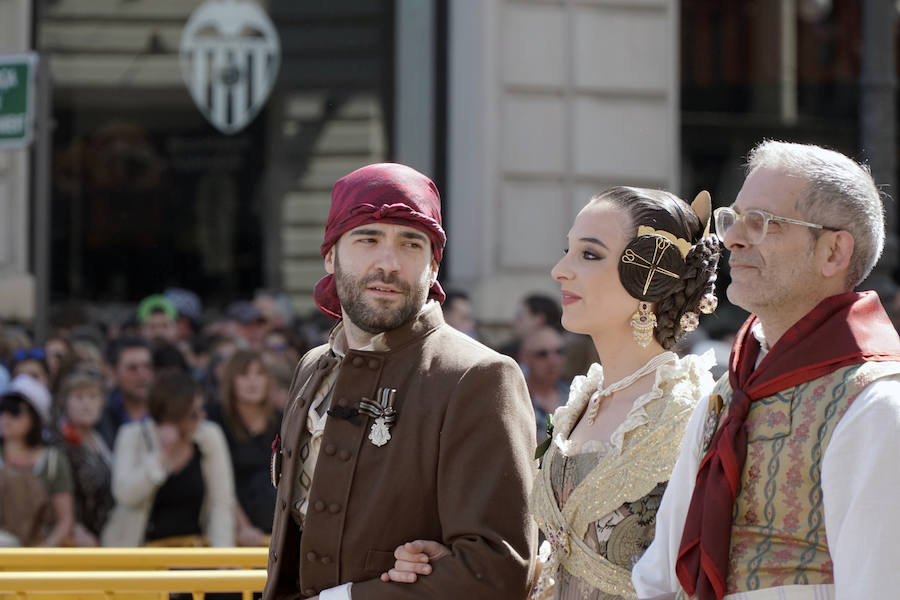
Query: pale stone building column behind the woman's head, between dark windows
445 0 680 325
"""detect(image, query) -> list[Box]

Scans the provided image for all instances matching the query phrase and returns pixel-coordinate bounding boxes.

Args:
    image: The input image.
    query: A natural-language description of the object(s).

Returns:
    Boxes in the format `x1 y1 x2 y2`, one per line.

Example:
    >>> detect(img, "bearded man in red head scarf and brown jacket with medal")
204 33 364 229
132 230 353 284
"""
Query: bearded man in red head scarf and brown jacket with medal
263 164 536 600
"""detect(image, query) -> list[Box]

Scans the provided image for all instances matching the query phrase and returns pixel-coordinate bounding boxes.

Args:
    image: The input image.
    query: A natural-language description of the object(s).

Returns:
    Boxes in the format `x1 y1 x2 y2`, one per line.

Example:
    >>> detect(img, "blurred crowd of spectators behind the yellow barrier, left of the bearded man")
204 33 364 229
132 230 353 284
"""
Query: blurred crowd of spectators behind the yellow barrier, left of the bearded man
0 289 322 547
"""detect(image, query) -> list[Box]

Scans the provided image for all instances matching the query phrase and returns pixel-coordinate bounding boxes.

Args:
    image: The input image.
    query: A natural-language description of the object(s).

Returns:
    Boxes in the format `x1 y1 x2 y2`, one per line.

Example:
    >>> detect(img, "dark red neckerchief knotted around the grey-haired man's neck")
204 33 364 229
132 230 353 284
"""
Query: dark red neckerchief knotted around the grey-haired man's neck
675 291 900 600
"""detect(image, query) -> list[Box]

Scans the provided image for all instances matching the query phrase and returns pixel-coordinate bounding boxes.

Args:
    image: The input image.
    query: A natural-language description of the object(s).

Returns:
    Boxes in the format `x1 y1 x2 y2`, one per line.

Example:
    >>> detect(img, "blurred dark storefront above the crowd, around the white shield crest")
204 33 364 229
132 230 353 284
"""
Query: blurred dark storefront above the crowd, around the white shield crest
36 0 394 314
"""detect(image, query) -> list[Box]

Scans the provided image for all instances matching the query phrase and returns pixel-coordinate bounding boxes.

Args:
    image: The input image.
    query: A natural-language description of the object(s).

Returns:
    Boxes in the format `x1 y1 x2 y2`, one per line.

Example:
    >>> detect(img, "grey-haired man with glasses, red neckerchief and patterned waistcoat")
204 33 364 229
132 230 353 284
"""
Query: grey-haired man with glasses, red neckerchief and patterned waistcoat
633 142 900 600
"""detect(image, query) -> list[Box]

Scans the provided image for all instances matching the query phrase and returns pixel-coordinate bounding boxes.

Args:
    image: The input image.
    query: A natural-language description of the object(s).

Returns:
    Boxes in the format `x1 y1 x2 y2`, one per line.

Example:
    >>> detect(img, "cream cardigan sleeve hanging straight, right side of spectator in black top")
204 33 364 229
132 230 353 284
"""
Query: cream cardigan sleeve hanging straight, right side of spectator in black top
194 421 235 547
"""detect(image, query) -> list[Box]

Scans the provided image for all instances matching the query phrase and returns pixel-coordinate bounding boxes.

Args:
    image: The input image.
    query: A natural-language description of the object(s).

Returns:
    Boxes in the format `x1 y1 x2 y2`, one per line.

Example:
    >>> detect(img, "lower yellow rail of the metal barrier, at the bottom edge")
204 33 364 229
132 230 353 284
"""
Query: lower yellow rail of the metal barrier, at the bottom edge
0 569 266 600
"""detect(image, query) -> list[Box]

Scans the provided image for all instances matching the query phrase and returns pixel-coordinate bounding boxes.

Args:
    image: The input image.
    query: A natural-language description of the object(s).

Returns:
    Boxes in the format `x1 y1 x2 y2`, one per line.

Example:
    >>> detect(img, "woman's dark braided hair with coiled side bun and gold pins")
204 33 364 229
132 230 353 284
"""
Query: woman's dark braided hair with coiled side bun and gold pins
592 186 721 350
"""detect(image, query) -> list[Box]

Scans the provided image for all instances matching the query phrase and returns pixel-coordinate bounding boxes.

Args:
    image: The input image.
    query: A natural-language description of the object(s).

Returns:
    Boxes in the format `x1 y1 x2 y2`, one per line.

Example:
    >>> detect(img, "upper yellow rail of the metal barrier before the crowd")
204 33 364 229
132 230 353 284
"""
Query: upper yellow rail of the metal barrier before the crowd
0 548 268 571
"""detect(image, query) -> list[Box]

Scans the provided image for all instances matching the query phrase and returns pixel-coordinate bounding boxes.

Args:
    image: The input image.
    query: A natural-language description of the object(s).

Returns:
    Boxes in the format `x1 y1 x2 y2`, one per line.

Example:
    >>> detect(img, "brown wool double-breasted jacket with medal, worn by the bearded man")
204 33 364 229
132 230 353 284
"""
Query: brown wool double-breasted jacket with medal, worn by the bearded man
263 303 537 600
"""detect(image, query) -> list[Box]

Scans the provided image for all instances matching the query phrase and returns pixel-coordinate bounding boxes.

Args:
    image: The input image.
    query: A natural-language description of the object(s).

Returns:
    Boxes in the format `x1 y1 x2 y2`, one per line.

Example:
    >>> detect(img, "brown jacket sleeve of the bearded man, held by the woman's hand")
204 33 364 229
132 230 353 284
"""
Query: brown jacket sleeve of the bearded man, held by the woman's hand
351 357 537 600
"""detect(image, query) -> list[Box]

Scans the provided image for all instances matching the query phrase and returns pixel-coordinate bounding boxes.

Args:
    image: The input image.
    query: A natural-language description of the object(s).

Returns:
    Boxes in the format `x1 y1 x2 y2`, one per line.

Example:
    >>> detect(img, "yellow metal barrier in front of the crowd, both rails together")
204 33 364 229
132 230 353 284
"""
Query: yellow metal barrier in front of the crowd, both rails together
0 548 268 600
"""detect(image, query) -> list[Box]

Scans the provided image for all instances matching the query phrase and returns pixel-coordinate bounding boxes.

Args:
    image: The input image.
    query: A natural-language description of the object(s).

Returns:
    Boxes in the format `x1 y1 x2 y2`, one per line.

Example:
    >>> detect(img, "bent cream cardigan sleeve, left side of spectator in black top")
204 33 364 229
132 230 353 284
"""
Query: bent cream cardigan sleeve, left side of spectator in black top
112 423 167 506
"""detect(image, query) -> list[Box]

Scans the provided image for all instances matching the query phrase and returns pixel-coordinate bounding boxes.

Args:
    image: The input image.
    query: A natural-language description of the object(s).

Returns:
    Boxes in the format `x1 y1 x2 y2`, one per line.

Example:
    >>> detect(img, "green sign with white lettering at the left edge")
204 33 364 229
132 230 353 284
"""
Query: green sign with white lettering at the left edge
0 52 37 148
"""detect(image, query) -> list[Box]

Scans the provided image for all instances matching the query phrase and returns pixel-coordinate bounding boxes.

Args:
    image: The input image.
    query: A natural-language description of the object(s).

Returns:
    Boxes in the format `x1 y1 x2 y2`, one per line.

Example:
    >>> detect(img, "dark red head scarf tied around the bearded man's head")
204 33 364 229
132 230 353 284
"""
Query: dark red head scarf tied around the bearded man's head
313 163 447 319
